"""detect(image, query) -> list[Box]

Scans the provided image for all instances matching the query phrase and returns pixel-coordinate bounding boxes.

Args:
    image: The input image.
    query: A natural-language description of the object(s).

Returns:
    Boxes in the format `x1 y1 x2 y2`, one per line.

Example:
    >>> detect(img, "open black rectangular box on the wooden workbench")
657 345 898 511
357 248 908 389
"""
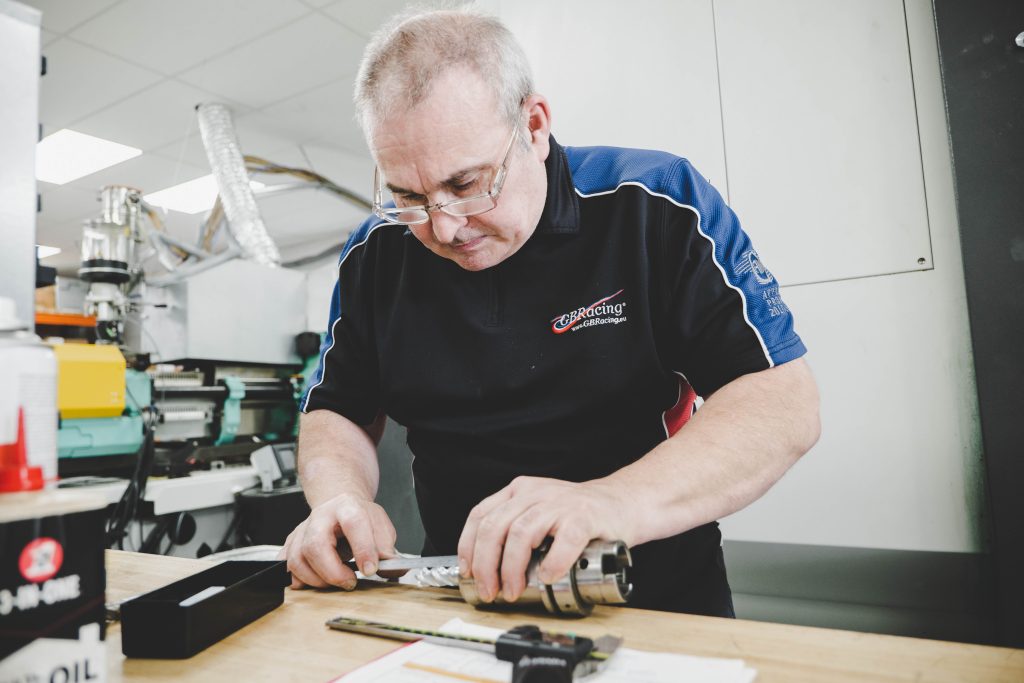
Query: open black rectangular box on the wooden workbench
121 560 290 659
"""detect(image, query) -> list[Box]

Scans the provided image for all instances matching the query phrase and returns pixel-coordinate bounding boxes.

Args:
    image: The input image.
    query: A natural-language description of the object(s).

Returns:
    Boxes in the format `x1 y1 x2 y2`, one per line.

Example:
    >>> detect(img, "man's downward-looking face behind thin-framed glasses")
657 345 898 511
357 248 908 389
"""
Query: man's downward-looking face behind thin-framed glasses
371 69 548 270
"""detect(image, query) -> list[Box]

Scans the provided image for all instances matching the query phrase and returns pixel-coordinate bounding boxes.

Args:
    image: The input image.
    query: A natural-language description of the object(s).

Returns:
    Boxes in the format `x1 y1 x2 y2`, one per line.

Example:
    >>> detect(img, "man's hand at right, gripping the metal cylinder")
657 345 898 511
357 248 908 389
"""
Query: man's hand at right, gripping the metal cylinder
459 476 636 602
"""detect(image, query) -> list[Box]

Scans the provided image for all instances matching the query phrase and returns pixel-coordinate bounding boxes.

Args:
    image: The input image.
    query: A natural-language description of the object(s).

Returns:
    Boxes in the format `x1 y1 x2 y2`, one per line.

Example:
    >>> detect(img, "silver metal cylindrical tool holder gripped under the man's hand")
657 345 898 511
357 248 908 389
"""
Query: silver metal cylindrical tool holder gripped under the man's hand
459 541 633 616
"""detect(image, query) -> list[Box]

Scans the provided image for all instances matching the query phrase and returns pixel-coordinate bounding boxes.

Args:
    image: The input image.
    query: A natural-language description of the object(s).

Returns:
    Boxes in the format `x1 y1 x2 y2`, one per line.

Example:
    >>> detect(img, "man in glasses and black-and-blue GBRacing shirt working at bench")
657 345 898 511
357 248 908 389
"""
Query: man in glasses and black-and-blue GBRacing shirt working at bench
284 5 818 615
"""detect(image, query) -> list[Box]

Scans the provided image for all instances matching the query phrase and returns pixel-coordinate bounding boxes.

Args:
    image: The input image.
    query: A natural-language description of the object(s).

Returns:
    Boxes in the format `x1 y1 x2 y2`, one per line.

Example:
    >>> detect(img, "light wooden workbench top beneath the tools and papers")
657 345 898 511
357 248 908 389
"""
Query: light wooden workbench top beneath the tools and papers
106 550 1024 683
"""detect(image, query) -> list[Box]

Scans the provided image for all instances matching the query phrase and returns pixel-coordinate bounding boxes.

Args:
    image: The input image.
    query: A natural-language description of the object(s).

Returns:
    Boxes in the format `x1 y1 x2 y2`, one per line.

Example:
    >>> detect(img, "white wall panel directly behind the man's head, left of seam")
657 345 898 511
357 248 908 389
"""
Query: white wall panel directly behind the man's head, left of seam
490 0 728 196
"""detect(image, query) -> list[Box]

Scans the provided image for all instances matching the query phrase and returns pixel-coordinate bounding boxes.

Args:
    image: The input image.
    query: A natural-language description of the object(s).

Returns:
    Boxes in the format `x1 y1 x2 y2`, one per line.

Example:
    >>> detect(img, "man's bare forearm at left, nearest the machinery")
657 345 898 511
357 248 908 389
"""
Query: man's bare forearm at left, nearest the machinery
298 410 384 507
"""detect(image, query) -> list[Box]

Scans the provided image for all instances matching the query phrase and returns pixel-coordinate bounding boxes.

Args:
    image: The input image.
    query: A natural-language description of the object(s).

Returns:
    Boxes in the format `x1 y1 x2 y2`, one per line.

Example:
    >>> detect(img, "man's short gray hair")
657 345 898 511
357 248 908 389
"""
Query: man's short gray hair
355 5 534 140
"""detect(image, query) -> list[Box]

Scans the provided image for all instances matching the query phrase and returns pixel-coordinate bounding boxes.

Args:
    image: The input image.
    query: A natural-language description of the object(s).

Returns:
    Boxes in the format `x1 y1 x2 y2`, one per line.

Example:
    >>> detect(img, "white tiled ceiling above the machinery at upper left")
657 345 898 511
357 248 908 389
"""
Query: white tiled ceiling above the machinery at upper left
28 0 406 274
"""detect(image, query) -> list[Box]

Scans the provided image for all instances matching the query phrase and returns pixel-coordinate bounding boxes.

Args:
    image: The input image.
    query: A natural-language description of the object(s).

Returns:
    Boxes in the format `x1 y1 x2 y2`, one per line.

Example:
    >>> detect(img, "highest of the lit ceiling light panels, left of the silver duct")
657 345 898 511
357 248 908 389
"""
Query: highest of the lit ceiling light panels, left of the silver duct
36 128 142 185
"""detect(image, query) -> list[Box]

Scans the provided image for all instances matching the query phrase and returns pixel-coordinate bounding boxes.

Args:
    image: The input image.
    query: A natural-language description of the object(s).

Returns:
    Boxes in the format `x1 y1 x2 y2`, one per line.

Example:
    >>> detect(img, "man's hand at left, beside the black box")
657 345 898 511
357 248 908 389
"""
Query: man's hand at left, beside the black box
278 494 397 591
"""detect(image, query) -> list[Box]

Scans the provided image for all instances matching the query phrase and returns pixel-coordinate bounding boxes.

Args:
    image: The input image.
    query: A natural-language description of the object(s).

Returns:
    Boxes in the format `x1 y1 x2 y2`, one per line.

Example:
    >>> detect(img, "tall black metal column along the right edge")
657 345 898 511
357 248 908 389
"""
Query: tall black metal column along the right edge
934 0 1024 647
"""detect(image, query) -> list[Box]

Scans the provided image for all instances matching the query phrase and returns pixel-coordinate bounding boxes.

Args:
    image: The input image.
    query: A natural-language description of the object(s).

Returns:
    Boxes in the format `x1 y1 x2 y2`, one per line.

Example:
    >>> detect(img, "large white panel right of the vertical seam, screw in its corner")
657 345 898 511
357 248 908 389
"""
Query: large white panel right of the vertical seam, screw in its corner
715 0 932 285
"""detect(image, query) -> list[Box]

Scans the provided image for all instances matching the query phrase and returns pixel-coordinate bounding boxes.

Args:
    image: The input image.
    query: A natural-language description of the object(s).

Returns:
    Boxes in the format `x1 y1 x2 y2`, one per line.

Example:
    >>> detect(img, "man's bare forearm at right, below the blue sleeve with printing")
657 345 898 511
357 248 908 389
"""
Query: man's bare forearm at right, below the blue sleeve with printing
594 360 820 545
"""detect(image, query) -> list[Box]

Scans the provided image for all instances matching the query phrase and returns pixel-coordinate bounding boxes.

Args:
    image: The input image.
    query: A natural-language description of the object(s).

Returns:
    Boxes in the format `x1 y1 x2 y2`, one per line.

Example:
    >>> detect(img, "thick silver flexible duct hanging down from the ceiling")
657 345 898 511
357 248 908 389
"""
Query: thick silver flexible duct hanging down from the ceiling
196 102 281 266
